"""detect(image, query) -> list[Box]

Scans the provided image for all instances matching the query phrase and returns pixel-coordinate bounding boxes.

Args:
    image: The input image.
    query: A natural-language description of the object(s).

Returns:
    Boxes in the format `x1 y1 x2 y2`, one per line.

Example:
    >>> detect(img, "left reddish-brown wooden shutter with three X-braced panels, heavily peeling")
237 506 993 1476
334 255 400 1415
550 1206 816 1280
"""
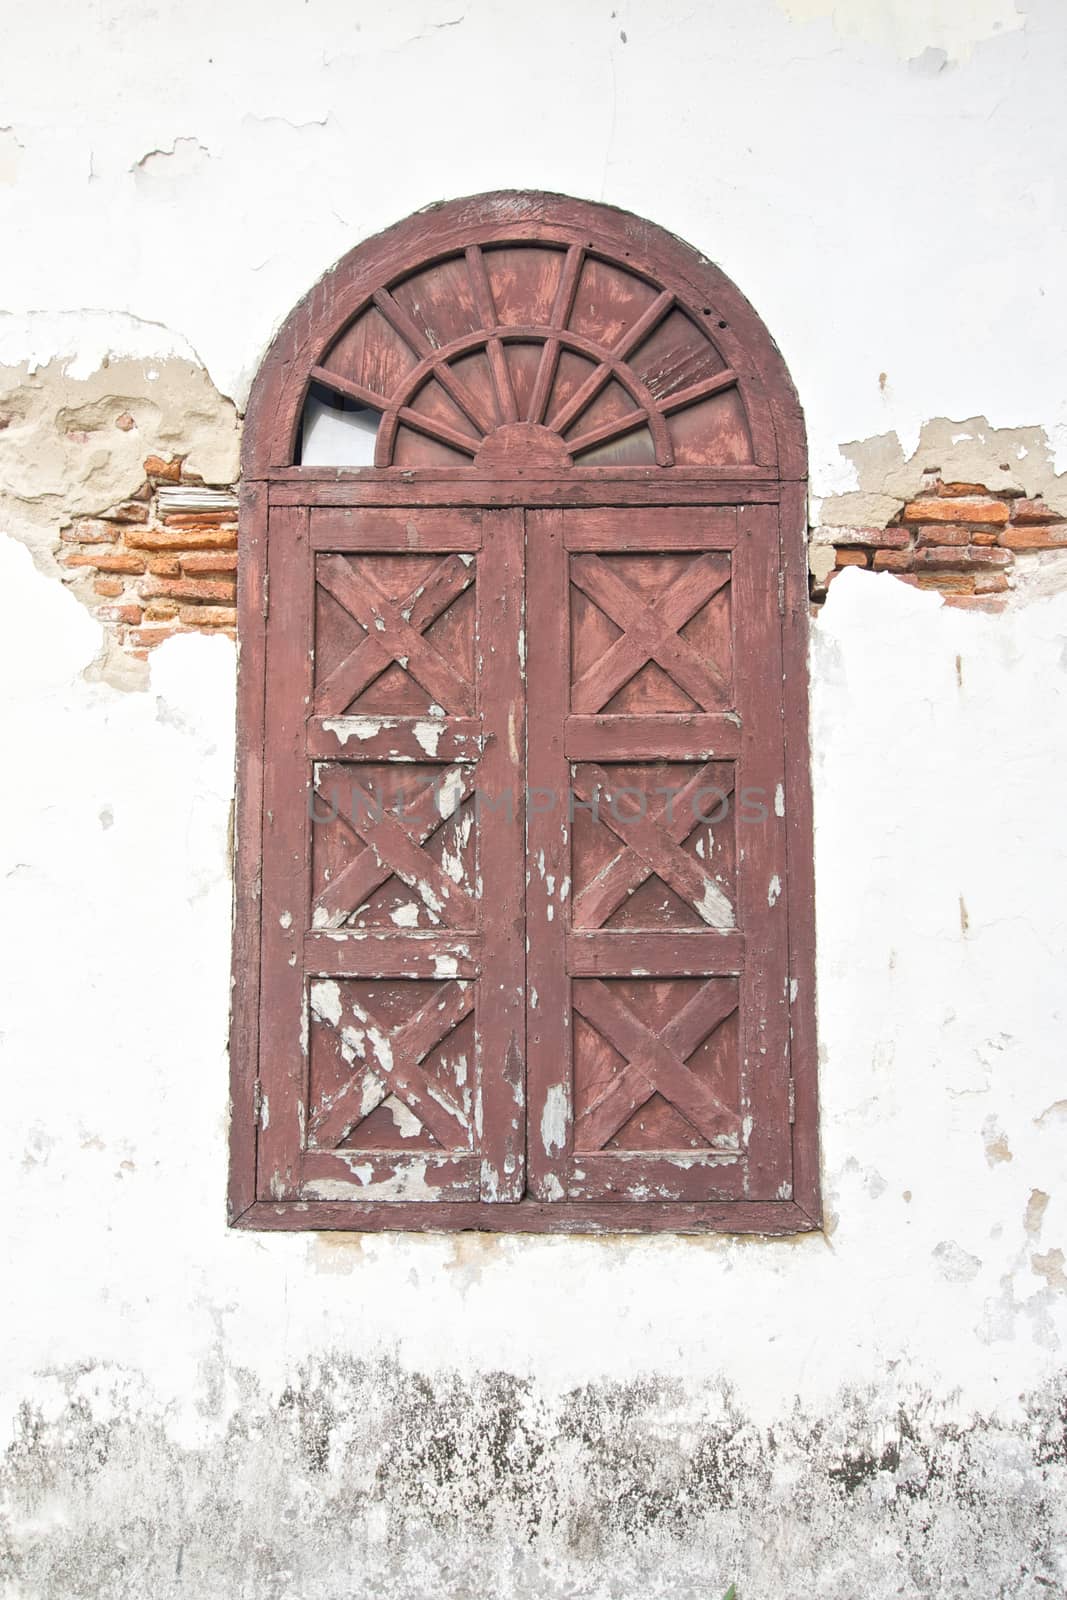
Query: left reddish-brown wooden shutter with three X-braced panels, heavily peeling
258 509 525 1205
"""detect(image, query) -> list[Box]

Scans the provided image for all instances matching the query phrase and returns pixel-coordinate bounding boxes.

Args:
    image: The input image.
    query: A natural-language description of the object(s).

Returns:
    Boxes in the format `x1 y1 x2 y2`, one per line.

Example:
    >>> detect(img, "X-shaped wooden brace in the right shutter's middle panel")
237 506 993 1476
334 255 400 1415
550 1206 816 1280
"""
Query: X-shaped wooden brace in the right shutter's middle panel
571 763 734 928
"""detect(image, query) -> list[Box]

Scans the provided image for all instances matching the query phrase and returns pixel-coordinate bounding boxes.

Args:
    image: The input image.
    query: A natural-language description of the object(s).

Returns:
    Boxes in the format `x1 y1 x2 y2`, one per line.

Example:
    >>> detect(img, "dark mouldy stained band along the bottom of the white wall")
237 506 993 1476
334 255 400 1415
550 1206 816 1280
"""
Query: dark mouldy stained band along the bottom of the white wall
0 1357 1067 1600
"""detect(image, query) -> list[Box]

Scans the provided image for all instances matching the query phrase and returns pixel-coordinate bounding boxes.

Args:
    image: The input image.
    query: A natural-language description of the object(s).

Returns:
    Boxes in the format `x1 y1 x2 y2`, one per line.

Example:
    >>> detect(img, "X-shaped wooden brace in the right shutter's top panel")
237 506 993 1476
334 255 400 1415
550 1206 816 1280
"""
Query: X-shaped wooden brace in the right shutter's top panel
571 554 729 714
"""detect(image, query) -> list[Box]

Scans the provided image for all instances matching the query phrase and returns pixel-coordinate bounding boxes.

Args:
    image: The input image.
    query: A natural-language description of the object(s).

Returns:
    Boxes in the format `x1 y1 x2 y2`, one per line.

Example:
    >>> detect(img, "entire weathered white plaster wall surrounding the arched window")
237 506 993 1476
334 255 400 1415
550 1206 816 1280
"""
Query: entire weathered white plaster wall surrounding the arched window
0 0 1067 1600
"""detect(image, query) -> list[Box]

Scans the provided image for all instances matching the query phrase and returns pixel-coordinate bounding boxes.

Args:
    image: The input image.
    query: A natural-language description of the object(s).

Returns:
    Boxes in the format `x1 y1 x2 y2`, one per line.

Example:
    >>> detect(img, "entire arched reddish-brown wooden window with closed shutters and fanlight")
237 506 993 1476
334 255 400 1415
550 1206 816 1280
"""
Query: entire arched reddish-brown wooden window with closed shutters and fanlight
230 194 817 1232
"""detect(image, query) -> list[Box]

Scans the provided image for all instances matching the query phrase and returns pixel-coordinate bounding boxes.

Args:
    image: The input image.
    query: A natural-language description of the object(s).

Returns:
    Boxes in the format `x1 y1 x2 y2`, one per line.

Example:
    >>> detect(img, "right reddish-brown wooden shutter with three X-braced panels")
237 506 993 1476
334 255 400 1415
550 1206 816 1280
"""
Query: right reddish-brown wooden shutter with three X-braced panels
528 509 790 1206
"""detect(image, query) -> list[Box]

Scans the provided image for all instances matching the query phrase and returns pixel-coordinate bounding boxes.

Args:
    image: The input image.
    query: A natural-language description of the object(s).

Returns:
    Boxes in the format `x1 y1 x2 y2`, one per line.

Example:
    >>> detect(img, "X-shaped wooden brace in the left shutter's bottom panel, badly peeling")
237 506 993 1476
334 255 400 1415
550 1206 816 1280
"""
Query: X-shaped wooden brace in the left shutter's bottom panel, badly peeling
307 981 474 1150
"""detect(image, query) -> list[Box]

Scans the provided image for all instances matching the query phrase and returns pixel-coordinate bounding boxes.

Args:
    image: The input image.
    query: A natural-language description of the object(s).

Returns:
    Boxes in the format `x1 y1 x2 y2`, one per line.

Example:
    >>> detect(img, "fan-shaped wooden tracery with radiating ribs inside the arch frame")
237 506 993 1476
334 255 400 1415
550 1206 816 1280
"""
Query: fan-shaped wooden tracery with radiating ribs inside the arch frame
295 243 753 467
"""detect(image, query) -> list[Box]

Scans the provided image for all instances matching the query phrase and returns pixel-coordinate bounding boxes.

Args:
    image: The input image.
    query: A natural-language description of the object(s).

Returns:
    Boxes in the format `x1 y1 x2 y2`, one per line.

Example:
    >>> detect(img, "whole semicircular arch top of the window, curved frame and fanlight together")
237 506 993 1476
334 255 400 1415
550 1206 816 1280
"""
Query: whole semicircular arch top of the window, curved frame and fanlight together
242 192 806 480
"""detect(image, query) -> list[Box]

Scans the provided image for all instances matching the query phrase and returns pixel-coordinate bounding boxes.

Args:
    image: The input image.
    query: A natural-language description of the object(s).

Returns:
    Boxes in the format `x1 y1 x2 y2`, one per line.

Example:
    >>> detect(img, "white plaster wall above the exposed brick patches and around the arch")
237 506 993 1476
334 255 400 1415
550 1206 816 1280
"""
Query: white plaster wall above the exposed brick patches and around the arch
0 0 1067 494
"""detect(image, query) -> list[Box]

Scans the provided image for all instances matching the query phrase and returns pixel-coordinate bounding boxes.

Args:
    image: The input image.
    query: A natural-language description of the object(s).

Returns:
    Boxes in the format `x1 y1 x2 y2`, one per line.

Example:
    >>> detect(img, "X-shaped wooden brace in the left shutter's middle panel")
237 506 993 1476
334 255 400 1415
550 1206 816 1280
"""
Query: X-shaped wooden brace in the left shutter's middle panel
312 766 477 928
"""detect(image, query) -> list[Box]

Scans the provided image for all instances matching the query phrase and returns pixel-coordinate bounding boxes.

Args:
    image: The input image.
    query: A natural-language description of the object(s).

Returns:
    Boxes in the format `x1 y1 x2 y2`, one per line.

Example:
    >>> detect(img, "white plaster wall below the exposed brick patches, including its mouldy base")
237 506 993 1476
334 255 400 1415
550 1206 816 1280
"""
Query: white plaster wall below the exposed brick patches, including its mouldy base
0 541 1067 1600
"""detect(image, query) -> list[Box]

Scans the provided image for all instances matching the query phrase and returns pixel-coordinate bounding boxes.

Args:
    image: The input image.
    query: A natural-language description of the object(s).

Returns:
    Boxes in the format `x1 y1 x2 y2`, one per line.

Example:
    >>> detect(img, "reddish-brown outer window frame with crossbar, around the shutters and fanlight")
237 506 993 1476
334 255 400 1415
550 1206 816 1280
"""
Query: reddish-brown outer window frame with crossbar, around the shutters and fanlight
229 195 821 1234
